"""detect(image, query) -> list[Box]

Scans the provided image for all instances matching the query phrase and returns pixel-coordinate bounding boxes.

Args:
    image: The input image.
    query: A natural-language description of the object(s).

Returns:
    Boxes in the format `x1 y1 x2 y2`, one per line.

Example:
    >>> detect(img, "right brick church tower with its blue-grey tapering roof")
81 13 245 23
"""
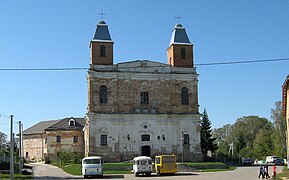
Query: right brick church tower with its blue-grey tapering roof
167 24 194 67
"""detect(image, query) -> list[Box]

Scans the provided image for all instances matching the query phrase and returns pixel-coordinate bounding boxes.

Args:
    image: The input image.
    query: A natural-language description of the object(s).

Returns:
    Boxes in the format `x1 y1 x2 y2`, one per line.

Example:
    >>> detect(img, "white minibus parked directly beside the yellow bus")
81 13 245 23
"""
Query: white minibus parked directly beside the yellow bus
132 156 152 176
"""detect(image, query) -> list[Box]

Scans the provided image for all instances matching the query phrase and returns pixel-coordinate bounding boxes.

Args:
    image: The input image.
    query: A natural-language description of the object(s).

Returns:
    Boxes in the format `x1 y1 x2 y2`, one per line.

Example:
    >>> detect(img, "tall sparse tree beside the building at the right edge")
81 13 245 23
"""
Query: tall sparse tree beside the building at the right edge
271 101 287 158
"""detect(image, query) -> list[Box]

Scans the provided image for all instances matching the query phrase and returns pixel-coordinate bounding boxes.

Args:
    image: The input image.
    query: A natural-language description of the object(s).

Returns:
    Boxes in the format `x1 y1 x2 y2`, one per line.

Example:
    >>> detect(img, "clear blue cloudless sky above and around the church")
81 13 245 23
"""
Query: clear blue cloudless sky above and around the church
0 0 289 135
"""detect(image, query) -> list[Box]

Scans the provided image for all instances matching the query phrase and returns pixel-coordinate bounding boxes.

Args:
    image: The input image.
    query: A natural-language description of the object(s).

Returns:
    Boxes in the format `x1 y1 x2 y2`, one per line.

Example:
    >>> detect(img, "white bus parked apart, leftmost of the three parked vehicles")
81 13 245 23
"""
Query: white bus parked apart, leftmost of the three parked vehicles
82 156 103 178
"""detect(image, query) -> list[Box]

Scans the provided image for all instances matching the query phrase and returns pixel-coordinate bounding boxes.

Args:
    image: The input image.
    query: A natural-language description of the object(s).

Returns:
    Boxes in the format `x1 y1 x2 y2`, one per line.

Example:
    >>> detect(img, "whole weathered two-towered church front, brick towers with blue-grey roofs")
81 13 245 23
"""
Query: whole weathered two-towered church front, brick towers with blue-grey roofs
84 21 202 161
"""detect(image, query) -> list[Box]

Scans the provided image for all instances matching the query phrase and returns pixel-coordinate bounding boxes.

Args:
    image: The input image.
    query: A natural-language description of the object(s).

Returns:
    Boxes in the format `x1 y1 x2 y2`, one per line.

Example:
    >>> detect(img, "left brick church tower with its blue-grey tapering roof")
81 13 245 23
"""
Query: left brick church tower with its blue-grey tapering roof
90 20 114 65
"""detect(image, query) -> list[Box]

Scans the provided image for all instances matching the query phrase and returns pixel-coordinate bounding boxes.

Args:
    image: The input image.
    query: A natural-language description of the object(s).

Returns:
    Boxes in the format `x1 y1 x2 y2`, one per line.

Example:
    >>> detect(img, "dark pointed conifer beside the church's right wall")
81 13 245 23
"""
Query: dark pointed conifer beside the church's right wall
201 109 218 160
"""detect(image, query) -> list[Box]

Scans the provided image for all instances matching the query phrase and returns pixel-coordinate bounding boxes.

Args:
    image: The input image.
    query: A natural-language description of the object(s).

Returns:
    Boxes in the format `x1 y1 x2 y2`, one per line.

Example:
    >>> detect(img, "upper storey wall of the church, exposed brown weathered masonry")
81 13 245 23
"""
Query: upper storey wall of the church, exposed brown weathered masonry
88 68 199 114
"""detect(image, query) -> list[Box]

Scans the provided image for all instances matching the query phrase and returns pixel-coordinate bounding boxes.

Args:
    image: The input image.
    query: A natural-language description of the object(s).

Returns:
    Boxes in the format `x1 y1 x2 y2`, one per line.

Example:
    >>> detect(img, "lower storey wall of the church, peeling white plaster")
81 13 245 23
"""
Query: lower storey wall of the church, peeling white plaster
87 113 201 161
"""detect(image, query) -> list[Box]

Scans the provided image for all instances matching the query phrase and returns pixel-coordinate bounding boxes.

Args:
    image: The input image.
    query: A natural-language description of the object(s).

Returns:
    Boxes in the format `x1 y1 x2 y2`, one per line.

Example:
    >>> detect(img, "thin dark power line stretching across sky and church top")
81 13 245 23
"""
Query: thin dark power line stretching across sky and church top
0 58 289 71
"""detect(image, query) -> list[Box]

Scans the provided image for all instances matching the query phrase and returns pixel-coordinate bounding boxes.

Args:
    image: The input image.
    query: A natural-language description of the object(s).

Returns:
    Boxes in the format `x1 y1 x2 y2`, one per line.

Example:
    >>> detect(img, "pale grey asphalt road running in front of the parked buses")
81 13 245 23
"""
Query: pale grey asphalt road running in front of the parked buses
32 163 283 180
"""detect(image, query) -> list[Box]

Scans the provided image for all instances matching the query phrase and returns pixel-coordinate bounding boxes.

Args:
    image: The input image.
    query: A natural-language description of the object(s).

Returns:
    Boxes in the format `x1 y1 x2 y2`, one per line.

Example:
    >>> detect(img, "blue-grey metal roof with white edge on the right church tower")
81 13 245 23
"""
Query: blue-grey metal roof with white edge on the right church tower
170 24 192 45
